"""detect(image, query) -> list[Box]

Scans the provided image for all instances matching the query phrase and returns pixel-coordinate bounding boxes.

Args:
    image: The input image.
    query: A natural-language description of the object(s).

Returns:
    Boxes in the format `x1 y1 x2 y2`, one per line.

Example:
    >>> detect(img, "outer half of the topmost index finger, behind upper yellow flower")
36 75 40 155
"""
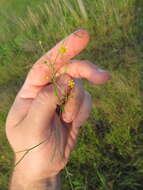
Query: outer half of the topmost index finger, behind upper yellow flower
36 29 89 69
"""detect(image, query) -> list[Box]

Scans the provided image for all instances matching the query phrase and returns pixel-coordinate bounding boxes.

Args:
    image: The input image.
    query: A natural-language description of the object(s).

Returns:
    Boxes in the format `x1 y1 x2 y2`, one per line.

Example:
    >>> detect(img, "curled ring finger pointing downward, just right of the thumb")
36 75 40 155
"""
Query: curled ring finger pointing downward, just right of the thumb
62 79 84 123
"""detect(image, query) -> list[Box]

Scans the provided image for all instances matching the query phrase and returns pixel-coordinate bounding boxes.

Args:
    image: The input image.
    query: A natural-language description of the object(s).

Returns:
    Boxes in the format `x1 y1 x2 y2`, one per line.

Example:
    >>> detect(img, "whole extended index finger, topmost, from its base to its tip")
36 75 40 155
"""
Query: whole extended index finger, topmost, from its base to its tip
10 30 89 127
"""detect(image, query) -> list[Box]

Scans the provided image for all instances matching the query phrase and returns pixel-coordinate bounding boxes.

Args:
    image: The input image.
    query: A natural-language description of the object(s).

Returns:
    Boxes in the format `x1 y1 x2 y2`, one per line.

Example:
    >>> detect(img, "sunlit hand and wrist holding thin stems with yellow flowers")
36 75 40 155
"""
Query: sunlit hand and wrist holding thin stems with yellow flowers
6 30 110 190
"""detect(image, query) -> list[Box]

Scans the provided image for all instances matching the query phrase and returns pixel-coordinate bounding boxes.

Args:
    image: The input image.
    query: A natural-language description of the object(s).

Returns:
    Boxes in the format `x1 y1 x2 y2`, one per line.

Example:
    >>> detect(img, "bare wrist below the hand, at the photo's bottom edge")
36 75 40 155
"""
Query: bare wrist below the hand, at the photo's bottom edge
10 154 60 190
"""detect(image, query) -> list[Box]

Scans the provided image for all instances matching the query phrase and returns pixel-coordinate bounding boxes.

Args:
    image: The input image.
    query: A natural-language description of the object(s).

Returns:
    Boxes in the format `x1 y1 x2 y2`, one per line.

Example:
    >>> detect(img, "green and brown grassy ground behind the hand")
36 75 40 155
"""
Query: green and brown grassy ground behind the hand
0 0 143 190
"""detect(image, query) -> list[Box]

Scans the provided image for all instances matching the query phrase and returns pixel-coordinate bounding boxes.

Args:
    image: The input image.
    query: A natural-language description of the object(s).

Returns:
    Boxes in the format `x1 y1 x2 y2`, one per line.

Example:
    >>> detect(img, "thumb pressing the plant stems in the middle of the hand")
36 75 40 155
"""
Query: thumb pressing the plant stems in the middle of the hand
27 75 71 126
